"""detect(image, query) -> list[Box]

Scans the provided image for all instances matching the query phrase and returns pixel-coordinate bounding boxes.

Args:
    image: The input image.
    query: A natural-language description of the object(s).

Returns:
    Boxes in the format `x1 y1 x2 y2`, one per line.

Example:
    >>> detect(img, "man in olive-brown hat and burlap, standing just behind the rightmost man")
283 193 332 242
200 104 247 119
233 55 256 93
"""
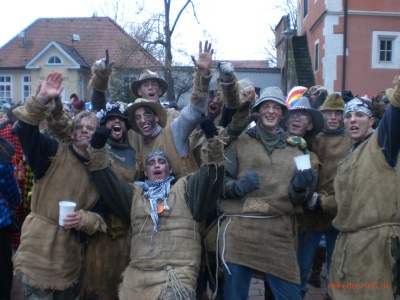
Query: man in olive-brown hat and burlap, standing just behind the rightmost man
297 93 352 295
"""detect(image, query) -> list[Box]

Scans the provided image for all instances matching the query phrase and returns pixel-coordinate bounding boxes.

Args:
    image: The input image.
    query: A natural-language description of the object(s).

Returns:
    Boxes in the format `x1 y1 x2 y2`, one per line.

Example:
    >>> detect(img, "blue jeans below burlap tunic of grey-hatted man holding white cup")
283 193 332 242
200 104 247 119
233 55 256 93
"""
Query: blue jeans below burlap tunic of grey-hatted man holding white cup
224 263 301 300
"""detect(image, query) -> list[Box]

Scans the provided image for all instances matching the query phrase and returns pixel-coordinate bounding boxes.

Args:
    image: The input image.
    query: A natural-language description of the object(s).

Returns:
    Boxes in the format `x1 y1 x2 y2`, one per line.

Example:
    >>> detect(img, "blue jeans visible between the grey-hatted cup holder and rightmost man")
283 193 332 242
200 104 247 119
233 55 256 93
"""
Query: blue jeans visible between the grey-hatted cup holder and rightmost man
297 227 339 295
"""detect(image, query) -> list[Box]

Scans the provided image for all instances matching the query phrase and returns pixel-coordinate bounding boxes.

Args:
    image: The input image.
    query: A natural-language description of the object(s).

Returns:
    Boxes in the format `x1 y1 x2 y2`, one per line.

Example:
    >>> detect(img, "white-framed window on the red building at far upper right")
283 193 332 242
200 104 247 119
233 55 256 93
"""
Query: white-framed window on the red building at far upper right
371 31 400 69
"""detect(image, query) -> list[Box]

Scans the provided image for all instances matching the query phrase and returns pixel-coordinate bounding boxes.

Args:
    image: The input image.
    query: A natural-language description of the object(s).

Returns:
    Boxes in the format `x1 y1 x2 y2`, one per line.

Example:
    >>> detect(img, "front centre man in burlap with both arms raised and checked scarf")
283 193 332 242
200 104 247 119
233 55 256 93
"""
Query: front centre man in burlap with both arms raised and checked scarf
85 113 226 300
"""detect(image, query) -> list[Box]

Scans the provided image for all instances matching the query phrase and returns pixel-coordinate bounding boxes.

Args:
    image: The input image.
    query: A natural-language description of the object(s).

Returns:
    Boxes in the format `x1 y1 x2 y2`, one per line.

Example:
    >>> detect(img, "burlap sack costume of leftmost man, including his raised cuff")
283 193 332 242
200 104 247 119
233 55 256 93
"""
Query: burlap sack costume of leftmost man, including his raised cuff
14 96 106 290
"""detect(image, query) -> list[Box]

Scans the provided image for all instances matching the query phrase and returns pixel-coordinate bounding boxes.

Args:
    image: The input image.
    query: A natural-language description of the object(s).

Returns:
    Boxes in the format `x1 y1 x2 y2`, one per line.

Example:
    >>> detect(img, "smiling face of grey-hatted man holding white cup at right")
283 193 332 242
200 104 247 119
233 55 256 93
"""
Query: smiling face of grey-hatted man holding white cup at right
258 100 283 133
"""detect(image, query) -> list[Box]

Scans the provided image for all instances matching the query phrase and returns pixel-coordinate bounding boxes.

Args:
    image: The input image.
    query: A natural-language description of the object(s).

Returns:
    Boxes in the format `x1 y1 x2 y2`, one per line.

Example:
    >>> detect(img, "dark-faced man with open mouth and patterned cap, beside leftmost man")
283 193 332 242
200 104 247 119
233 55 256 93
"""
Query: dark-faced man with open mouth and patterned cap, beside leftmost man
78 102 141 300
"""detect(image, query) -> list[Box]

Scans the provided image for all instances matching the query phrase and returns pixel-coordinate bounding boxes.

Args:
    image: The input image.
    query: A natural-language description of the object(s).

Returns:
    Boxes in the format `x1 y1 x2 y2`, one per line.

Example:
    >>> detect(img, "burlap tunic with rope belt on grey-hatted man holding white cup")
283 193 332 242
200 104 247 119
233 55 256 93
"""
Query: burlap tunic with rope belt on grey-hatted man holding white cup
219 134 305 284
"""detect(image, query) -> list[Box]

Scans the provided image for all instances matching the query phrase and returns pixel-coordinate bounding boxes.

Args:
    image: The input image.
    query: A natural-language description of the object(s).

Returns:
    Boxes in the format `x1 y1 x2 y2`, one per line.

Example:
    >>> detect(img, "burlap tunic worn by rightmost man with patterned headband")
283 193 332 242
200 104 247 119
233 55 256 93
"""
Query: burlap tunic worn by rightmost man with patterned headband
329 131 400 300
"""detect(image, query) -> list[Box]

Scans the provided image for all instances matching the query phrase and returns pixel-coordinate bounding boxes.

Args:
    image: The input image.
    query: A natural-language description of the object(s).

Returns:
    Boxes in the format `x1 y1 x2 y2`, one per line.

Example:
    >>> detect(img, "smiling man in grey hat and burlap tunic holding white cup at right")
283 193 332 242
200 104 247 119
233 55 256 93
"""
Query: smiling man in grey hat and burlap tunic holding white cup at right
218 87 317 299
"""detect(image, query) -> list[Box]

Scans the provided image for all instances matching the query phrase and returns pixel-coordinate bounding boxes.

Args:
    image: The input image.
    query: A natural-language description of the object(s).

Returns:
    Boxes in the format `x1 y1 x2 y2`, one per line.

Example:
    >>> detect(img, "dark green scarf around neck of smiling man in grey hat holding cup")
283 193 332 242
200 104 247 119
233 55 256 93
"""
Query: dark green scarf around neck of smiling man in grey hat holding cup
246 122 288 156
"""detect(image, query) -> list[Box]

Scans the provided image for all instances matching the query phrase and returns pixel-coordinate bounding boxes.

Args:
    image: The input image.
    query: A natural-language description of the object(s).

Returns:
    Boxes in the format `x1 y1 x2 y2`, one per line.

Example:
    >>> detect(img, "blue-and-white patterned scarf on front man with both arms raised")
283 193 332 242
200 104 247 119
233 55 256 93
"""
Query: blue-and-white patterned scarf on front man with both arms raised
142 176 175 234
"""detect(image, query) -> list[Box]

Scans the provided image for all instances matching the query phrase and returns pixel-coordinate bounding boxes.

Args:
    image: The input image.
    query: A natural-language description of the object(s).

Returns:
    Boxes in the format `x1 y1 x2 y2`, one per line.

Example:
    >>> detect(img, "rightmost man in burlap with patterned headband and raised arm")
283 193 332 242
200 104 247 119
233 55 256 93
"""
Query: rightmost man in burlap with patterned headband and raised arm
309 76 400 299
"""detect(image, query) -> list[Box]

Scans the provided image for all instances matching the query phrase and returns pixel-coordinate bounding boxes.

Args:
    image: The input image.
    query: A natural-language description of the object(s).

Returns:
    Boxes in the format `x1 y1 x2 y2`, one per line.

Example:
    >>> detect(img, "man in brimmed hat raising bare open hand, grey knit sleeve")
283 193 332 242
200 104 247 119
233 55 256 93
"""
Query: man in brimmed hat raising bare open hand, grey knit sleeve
122 41 214 178
